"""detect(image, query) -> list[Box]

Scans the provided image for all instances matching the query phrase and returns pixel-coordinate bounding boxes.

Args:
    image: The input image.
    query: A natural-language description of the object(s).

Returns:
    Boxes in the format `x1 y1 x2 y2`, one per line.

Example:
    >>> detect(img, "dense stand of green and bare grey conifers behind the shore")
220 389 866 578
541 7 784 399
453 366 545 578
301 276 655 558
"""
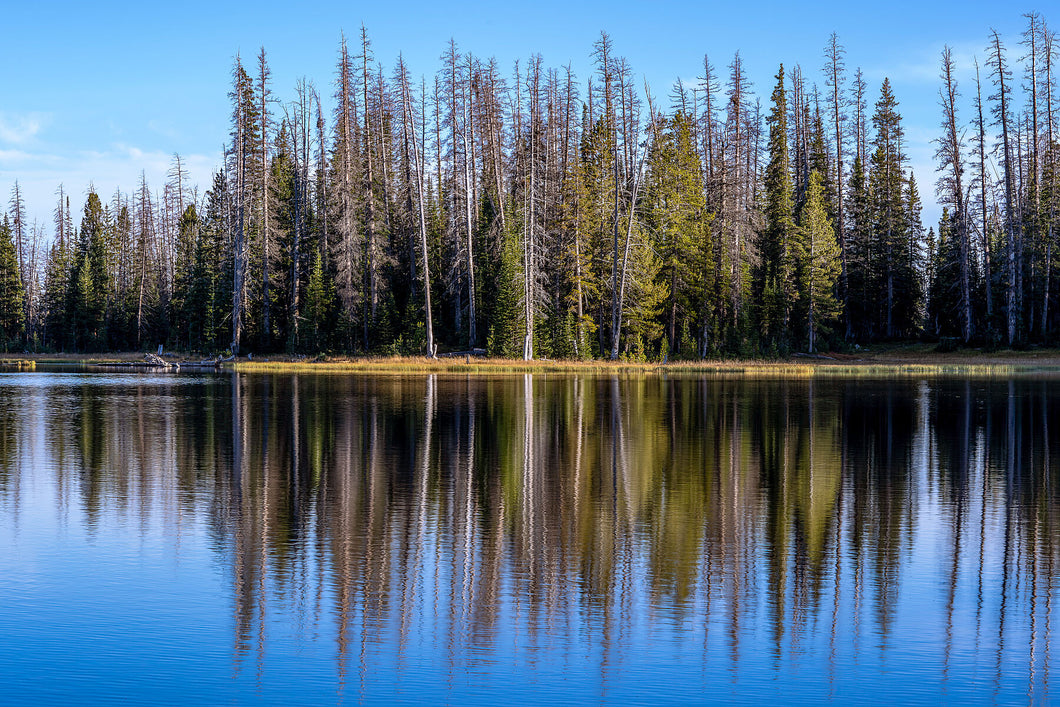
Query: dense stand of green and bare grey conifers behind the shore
0 14 1060 360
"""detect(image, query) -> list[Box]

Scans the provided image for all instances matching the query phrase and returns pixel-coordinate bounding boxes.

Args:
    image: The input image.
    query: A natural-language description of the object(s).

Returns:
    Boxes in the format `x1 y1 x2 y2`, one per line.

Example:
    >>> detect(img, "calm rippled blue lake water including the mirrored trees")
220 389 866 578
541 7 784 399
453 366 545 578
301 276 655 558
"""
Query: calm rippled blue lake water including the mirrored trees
0 371 1060 705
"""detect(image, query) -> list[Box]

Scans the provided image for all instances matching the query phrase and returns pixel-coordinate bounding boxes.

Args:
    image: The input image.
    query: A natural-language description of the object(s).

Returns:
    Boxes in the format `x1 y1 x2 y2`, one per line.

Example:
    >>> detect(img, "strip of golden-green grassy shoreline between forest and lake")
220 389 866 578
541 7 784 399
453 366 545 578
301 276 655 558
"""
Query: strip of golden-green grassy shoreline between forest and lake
6 344 1060 378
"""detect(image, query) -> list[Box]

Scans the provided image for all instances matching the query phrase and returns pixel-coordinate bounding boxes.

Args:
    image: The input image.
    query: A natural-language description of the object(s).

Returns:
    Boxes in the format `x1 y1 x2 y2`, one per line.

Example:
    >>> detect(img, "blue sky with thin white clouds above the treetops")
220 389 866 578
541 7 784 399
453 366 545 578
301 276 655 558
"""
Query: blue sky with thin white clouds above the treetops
0 0 1043 232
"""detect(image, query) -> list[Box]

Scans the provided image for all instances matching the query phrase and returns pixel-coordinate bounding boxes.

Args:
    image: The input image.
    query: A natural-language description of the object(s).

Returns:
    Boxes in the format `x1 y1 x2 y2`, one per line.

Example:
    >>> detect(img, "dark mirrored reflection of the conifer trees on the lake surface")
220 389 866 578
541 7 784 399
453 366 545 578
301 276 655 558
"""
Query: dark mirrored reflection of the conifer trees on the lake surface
0 375 1060 695
